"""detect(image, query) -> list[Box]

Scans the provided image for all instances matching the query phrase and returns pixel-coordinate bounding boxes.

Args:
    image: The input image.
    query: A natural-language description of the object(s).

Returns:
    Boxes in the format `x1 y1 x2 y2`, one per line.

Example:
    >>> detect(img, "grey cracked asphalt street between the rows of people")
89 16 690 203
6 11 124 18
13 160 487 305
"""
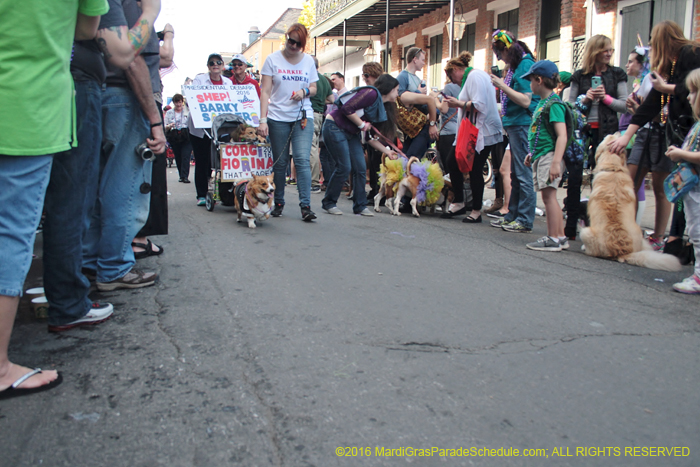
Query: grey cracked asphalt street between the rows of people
0 169 700 467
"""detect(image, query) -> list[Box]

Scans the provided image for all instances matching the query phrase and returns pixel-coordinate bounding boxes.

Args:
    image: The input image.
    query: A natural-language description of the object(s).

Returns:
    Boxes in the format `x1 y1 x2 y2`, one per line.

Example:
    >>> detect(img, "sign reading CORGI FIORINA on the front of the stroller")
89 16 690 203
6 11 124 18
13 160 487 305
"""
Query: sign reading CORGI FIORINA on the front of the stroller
219 143 274 182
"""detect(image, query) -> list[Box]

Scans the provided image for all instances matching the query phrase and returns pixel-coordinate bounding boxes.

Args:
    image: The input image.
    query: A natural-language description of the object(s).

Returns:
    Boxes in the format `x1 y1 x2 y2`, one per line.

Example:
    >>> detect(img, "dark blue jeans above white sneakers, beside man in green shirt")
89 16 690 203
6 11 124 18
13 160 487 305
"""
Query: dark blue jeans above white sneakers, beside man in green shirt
44 81 102 326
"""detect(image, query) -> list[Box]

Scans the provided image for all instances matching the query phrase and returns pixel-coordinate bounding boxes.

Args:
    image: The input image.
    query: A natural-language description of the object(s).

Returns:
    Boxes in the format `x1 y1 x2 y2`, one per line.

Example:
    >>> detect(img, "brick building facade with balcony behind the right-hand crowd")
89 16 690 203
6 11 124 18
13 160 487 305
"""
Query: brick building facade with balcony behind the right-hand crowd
311 0 700 86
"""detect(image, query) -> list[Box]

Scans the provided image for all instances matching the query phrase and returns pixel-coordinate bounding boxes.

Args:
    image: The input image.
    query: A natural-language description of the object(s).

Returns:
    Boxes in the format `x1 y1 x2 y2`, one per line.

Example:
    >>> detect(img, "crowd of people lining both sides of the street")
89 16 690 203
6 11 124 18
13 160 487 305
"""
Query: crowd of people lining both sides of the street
0 10 700 398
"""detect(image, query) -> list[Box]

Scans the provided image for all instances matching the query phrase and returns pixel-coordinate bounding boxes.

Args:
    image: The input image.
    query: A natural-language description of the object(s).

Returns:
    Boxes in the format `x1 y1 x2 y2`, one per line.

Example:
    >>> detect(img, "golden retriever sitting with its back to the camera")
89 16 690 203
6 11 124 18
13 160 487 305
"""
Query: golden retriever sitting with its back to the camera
581 133 681 271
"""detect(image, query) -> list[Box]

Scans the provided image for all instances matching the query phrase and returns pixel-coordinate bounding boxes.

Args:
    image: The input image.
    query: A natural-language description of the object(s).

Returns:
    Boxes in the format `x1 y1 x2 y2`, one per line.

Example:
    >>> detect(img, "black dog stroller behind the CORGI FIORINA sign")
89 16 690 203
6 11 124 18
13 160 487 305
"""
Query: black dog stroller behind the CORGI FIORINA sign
206 113 272 211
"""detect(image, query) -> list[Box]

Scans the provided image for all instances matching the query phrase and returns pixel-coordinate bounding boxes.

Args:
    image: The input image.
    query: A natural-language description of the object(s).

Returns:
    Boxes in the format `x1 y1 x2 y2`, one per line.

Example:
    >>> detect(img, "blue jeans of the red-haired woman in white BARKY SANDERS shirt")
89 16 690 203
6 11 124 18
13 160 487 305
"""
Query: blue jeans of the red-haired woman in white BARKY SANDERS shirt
267 120 314 206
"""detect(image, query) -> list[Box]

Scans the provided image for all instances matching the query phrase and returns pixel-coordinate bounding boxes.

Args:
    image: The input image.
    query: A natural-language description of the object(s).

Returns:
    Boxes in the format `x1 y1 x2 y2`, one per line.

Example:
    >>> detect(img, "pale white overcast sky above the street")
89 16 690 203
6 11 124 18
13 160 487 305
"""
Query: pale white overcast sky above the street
156 0 303 102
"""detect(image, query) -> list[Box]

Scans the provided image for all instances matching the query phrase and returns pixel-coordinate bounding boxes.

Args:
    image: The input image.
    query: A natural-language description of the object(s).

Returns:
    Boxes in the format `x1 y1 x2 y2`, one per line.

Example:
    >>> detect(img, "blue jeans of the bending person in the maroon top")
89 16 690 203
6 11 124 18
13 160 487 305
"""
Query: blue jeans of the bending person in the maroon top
322 118 367 214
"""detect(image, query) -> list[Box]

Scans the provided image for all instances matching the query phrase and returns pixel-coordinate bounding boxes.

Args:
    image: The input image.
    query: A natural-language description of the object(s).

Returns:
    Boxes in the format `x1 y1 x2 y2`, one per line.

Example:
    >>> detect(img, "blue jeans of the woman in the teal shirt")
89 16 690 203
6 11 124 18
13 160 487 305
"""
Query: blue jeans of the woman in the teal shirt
504 125 537 229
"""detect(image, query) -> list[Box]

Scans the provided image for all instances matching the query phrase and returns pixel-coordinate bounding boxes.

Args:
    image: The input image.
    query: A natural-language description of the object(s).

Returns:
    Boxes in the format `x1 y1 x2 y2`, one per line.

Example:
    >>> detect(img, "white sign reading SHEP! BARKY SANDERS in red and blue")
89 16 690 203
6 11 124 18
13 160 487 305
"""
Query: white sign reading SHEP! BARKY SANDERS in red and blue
182 84 260 128
